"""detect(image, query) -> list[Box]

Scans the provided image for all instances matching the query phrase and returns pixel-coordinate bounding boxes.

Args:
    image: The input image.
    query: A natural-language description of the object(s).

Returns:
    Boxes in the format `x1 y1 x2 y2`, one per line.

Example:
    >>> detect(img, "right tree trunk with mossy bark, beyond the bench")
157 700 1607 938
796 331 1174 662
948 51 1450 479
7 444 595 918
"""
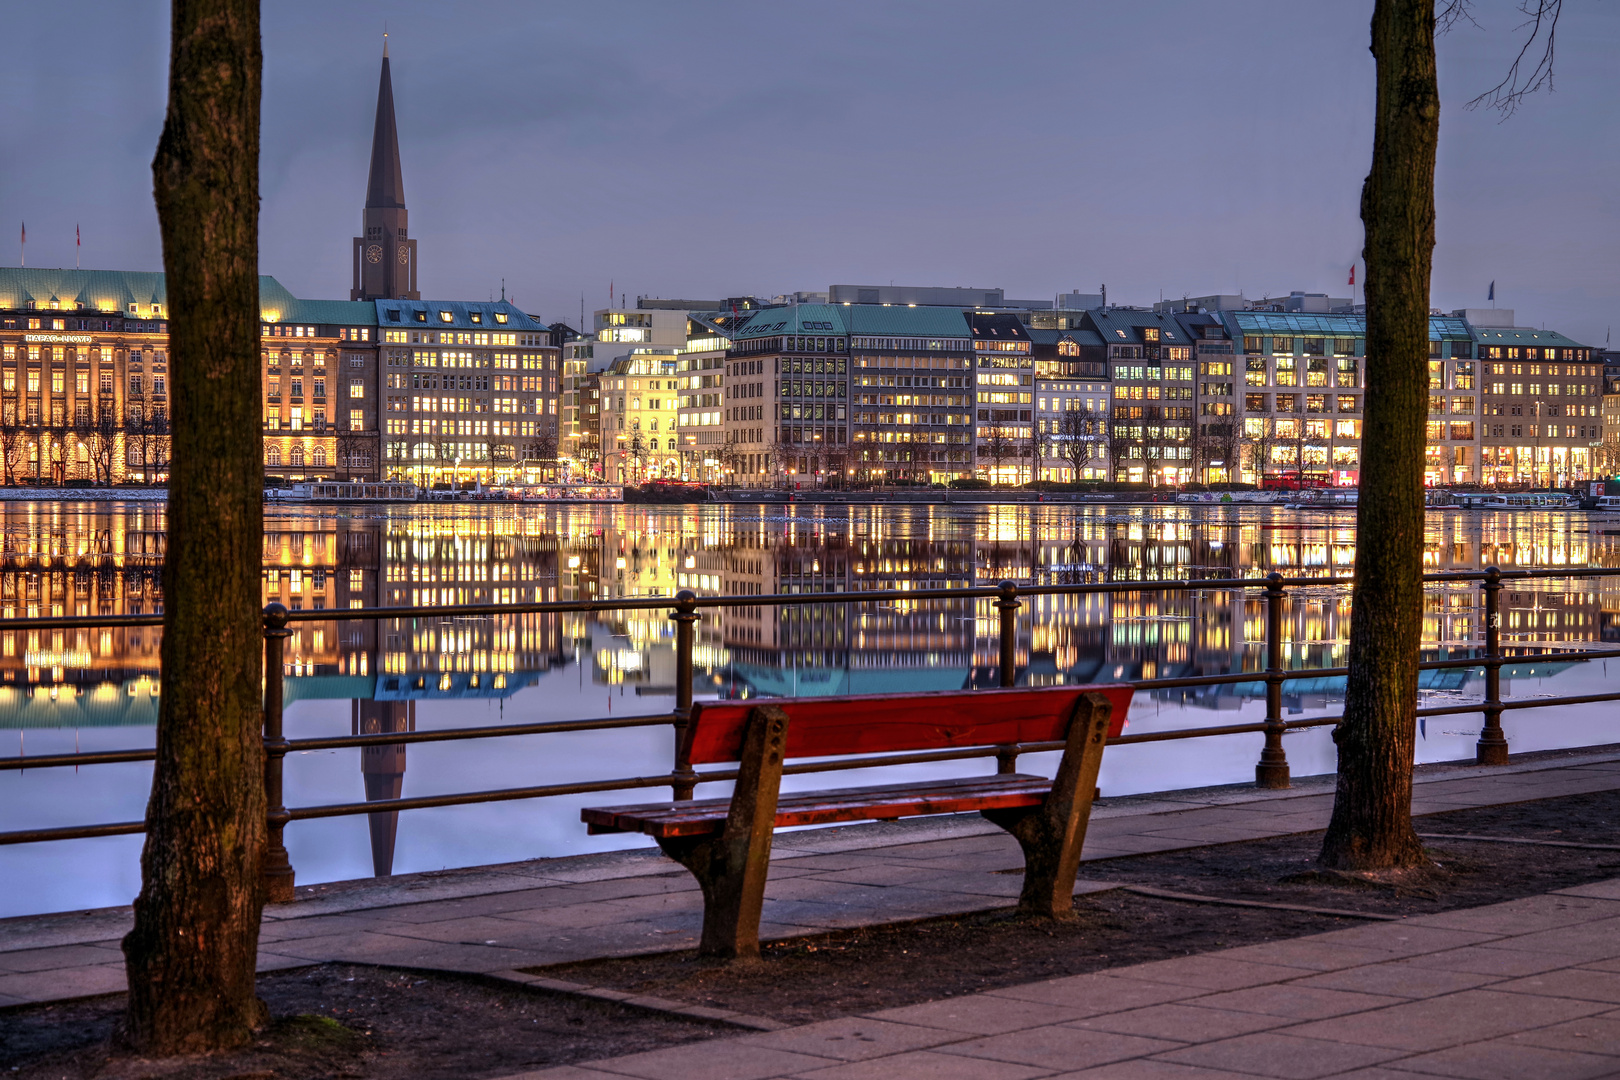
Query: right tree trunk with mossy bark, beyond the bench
1322 0 1440 870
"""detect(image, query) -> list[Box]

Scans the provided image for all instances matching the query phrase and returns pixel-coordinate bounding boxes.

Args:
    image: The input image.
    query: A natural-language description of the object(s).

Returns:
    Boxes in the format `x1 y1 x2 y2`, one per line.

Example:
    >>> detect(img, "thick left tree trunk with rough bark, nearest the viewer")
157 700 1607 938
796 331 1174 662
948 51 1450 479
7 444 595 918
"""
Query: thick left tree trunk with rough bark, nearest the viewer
123 0 266 1054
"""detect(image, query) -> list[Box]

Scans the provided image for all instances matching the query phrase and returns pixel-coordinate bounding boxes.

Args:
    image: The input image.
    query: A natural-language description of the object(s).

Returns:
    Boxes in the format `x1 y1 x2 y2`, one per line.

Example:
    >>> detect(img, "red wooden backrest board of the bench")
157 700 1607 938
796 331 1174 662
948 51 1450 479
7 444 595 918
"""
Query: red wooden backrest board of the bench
687 683 1131 764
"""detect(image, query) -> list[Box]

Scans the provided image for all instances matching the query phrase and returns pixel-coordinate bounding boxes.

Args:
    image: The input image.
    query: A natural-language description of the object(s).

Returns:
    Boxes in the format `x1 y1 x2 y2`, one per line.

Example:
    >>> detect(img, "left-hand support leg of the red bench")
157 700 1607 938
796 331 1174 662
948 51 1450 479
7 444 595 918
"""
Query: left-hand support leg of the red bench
658 704 787 959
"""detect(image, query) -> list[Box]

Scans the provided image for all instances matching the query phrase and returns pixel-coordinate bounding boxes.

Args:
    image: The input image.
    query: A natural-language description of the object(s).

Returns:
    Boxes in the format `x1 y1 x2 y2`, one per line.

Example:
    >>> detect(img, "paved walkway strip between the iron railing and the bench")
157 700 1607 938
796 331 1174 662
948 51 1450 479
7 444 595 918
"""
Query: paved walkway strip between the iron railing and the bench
0 748 1620 1006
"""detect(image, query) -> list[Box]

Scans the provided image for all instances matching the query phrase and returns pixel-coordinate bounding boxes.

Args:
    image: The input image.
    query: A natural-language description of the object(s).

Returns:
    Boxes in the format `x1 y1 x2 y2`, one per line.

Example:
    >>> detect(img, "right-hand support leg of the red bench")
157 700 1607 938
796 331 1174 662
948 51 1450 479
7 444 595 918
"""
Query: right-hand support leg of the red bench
980 693 1113 920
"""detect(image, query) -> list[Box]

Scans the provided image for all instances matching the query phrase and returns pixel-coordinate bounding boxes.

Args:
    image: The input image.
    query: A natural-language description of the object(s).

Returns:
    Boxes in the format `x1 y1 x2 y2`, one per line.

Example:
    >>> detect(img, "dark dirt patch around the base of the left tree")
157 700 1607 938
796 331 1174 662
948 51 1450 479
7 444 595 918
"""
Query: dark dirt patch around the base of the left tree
0 965 722 1080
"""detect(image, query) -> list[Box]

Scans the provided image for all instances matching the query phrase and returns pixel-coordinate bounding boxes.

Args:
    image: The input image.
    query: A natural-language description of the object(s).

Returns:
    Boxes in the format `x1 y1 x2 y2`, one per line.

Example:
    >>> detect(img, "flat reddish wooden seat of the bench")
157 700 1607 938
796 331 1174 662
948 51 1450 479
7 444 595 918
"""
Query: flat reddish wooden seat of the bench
580 774 1051 839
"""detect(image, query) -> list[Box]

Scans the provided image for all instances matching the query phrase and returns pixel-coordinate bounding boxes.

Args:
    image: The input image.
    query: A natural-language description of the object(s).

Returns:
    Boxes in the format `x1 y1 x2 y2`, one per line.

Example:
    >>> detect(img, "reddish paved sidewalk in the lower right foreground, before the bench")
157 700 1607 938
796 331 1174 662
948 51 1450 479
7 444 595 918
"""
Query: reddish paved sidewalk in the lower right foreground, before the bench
509 878 1620 1080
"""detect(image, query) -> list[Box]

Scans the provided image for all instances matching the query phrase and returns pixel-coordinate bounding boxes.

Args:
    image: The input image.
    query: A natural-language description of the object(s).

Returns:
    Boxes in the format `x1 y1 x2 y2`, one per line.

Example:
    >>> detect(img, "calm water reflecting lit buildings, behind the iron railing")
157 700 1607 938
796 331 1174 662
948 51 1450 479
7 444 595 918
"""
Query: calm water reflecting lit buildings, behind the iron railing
0 504 1620 915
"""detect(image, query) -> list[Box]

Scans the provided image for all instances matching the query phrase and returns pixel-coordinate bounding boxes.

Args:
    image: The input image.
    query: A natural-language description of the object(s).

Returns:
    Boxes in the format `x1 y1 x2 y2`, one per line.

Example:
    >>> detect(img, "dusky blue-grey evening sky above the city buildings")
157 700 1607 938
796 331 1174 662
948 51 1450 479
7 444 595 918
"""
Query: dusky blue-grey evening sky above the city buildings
0 0 1620 345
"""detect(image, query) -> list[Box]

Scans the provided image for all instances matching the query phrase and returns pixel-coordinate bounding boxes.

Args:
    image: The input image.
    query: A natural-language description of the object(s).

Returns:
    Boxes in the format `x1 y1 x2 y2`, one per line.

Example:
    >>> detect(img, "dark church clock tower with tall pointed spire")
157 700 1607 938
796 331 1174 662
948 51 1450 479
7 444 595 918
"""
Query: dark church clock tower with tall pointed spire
348 40 421 300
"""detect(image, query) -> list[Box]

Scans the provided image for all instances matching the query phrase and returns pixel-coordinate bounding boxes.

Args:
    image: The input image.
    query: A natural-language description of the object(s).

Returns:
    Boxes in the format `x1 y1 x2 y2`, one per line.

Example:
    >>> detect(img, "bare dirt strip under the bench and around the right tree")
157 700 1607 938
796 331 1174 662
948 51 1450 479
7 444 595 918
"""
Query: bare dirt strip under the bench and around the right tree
536 792 1620 1023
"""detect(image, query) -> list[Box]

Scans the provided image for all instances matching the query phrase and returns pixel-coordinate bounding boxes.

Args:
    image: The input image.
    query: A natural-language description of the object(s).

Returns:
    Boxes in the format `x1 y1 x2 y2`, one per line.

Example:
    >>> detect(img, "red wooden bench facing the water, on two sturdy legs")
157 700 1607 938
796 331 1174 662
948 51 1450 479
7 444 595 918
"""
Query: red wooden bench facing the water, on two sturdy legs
580 685 1131 957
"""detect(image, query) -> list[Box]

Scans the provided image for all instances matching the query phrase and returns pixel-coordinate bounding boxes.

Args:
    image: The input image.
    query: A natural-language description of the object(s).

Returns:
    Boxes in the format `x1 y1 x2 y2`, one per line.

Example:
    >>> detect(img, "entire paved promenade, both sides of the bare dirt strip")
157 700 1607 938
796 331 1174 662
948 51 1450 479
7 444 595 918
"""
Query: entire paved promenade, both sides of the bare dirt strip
0 748 1620 1080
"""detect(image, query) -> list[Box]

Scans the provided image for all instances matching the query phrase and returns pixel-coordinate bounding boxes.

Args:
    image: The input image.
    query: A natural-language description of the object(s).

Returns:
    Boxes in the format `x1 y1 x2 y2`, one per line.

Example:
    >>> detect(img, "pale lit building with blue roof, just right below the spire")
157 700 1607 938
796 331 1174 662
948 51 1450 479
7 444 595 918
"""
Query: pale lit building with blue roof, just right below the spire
373 300 561 486
